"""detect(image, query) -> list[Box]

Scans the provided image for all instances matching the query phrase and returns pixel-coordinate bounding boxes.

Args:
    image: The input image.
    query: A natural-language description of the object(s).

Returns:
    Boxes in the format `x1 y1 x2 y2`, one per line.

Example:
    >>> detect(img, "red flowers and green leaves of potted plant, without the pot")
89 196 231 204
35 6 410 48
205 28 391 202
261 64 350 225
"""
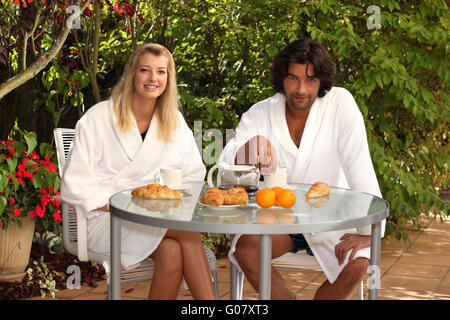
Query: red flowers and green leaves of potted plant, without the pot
0 128 61 232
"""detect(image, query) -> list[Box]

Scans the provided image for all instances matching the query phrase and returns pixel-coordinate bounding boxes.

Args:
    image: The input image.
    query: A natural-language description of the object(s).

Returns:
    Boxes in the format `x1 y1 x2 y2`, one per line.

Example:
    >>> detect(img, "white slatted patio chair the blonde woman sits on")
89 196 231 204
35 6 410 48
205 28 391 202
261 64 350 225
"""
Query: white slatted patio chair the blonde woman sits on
53 128 219 299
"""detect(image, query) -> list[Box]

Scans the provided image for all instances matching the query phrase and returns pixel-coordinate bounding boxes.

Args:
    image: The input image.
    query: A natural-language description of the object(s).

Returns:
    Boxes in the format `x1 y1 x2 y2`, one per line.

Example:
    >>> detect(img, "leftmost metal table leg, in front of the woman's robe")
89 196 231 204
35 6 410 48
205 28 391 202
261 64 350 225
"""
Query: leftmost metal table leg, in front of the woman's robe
110 214 121 300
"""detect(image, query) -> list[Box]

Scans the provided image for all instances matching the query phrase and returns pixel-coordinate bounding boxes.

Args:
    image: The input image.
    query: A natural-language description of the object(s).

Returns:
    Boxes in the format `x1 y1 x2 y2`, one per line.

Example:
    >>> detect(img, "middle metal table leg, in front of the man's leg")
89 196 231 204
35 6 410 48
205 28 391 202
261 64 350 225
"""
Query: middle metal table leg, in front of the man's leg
259 234 272 300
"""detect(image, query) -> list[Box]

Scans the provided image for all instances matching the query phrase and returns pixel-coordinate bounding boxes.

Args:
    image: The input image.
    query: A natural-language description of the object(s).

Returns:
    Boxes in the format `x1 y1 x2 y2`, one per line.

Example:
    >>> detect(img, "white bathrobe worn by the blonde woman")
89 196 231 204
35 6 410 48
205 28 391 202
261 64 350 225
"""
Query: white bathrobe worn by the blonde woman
61 100 206 268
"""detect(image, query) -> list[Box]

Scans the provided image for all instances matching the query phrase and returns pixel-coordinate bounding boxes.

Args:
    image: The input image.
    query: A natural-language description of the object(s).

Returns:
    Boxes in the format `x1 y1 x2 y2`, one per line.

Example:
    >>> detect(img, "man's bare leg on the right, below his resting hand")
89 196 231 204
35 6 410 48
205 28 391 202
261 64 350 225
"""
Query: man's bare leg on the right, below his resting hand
314 258 370 300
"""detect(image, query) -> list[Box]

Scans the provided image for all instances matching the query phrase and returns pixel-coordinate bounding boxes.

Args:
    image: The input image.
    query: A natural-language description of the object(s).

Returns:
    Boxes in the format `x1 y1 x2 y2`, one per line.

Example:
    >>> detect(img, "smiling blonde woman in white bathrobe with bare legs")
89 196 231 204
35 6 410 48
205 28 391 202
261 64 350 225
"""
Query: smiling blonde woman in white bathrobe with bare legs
61 44 215 299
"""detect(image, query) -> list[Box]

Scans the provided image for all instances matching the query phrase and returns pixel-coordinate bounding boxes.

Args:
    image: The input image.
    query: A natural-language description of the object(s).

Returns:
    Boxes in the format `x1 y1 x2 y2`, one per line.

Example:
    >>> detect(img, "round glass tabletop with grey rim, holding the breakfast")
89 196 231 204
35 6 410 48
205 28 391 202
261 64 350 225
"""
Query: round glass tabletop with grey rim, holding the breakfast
109 182 389 234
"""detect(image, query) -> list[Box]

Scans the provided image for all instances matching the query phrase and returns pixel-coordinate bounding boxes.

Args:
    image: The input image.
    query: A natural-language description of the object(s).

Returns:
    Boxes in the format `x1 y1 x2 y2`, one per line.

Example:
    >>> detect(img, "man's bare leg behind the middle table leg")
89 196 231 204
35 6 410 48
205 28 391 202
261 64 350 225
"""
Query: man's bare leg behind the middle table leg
235 234 294 300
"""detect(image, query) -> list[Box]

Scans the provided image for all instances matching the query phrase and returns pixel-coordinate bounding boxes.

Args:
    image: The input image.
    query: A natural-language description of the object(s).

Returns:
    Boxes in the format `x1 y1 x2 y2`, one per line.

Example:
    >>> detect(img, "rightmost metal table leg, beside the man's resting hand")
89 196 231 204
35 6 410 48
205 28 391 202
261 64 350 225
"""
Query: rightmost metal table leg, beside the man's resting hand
368 222 381 300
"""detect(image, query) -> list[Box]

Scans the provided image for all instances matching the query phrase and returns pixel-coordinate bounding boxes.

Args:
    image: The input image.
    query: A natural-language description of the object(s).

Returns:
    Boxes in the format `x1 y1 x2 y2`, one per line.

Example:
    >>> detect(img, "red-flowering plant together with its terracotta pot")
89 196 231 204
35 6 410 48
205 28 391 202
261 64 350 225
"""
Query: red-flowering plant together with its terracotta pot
0 128 61 281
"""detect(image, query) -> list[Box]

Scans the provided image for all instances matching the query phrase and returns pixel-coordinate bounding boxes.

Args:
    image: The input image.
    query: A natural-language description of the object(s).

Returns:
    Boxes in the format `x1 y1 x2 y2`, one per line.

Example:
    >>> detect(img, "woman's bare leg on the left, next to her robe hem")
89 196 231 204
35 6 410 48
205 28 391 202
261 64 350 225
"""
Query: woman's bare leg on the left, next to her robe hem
148 238 183 300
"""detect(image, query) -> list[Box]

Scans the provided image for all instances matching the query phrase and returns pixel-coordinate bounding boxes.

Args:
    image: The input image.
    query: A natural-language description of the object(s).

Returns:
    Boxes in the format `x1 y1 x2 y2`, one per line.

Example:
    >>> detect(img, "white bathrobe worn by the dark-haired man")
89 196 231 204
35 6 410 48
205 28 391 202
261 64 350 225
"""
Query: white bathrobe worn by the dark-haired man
219 87 385 283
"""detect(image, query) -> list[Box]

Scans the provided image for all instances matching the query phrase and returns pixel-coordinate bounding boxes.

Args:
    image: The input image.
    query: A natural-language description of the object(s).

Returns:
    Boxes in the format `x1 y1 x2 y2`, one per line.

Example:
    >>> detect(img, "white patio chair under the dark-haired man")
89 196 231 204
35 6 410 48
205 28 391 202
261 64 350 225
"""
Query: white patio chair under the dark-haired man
230 236 364 300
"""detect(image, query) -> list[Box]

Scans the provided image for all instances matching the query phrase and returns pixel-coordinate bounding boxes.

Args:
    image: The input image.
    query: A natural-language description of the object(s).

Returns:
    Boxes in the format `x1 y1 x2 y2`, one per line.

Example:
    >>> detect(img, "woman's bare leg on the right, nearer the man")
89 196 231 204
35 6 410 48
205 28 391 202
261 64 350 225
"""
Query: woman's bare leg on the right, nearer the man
165 230 216 300
